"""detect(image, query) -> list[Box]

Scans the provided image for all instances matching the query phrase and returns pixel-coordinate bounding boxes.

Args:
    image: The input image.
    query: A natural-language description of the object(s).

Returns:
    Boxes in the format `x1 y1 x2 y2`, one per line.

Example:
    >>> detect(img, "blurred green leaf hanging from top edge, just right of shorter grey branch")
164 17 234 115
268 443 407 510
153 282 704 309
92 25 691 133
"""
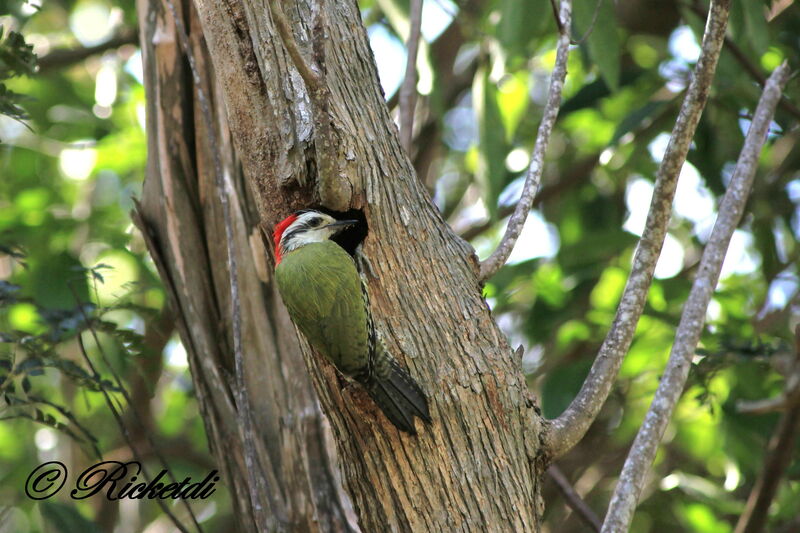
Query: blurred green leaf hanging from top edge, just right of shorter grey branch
574 0 621 91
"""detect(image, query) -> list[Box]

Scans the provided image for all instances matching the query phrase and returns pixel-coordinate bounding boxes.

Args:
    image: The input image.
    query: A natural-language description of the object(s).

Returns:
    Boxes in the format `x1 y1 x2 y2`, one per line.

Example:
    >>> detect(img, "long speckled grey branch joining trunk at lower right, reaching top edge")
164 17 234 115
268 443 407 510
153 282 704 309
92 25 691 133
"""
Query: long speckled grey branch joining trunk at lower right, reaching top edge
545 0 731 458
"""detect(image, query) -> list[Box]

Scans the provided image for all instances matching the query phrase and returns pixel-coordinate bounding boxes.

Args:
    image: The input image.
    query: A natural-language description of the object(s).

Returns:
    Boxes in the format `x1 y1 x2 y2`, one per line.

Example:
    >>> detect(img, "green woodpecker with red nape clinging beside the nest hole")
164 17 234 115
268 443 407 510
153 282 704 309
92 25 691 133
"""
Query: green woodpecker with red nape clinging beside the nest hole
273 210 431 434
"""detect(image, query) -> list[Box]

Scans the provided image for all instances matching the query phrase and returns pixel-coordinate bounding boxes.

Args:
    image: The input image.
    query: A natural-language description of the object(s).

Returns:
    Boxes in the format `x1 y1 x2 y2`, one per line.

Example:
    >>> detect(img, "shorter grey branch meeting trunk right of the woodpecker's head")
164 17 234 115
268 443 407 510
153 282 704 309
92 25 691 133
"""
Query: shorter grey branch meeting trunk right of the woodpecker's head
479 0 572 281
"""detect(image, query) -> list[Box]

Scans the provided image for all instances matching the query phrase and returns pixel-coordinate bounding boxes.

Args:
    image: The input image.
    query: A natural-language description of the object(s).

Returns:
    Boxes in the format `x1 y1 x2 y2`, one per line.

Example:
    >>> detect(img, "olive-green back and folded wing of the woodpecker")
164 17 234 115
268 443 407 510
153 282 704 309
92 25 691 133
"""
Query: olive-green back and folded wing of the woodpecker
275 241 369 375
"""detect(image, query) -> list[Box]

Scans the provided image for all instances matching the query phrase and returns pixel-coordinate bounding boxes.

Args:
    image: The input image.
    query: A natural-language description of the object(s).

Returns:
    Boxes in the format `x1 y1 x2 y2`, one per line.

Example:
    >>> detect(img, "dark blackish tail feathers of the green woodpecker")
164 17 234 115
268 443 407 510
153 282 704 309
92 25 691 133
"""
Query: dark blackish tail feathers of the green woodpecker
364 358 431 435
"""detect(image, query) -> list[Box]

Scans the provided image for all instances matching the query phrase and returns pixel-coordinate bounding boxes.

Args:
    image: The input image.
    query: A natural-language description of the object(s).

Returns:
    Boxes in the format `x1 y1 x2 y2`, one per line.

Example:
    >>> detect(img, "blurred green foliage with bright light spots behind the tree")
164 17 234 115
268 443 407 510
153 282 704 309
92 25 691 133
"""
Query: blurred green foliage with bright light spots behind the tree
0 0 800 533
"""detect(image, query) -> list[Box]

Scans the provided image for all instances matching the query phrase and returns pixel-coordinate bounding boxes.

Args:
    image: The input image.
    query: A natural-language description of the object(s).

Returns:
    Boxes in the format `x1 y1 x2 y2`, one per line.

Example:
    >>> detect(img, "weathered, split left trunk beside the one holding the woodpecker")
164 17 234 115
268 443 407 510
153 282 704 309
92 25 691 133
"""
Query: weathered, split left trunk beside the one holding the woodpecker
135 0 355 531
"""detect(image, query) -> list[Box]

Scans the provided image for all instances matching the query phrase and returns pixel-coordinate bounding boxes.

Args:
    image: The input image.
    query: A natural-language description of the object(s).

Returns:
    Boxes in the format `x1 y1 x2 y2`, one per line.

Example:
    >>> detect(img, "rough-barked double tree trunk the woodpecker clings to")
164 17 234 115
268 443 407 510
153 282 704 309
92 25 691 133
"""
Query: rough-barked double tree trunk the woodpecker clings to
138 0 544 532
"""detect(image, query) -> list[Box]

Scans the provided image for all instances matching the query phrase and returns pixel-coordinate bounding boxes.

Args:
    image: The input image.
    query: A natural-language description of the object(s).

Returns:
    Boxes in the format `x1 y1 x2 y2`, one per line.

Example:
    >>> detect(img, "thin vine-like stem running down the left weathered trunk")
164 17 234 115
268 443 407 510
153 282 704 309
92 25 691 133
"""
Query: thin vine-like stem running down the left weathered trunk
161 0 282 531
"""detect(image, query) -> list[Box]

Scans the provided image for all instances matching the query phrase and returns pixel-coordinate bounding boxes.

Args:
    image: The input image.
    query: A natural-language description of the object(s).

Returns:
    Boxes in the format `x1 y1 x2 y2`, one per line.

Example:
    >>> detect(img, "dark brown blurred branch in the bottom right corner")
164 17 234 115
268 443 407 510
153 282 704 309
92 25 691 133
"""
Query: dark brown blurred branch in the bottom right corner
734 324 800 533
